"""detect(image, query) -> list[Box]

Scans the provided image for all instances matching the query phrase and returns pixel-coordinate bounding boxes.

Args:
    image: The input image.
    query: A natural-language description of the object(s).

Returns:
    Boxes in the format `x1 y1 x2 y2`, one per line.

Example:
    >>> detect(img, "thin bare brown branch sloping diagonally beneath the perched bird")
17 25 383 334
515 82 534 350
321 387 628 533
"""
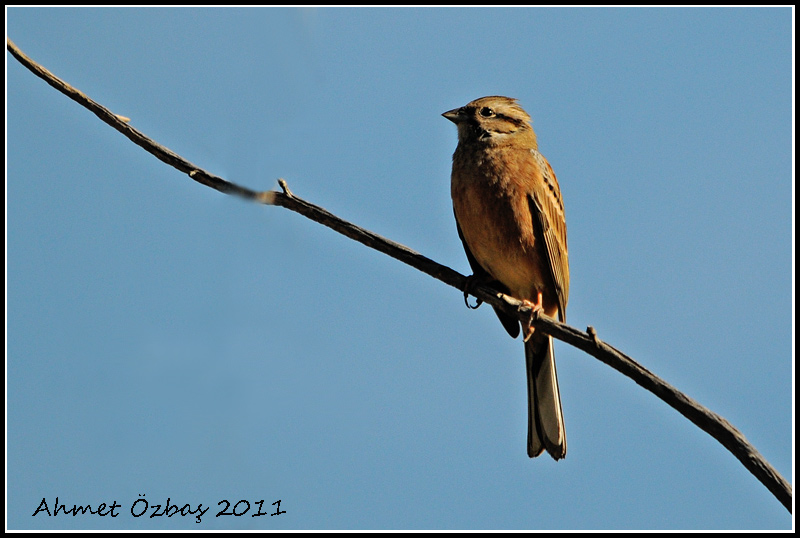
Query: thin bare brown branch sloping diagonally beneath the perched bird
6 39 792 513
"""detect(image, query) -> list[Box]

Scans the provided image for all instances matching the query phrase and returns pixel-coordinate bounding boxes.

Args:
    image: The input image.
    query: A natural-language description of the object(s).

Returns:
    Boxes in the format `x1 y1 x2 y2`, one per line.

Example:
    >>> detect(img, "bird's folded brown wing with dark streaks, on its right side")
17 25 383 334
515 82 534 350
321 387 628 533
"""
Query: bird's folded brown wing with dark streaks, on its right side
528 150 569 321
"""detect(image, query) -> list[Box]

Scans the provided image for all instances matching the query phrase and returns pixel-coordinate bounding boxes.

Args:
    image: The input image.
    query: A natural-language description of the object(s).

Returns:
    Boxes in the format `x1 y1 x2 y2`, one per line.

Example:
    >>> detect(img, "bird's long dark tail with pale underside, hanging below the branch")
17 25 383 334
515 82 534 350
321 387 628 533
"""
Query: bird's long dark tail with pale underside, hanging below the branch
525 334 567 460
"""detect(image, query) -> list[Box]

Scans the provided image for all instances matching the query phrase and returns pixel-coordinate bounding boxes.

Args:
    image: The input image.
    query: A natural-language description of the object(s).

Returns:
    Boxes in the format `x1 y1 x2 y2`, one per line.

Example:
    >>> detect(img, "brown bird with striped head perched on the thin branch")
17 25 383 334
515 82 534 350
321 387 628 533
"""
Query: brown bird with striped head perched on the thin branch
442 95 569 460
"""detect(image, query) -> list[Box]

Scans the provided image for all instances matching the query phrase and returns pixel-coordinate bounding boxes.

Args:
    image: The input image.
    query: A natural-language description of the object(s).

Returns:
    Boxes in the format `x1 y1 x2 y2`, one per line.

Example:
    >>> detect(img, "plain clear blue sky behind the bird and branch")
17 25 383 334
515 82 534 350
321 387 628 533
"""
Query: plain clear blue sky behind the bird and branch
6 8 794 530
